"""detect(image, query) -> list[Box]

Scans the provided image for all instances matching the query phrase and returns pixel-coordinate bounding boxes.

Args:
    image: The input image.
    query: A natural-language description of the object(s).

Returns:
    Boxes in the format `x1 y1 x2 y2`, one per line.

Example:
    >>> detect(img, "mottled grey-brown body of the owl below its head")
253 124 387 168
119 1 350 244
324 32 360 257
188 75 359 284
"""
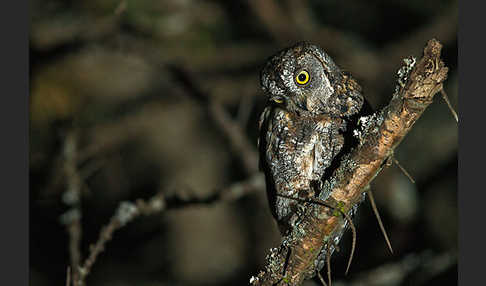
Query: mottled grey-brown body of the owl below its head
259 106 345 225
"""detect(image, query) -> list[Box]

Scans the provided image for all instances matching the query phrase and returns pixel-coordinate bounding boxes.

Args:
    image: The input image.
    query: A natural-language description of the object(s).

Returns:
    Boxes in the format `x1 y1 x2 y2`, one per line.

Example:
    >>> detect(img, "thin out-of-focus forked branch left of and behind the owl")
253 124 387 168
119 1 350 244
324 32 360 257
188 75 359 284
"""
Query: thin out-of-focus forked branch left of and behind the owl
62 61 265 285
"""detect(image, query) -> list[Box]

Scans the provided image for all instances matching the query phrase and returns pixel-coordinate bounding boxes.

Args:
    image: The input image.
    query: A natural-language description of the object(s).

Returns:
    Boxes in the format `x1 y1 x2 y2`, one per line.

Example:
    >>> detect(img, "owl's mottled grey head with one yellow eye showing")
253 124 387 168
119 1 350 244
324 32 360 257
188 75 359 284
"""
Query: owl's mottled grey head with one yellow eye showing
261 42 363 116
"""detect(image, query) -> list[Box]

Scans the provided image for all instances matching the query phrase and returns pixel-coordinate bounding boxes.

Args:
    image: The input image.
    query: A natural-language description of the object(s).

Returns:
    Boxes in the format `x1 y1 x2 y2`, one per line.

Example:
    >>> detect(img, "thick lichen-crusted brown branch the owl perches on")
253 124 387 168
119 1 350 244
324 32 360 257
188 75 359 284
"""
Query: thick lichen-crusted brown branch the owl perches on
251 39 448 285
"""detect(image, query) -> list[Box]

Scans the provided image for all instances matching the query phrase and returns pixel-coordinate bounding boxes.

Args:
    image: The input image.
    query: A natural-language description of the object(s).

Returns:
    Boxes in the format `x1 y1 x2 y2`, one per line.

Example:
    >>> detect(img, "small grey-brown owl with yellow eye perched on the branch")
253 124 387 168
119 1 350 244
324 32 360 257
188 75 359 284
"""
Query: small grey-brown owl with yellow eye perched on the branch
258 42 365 234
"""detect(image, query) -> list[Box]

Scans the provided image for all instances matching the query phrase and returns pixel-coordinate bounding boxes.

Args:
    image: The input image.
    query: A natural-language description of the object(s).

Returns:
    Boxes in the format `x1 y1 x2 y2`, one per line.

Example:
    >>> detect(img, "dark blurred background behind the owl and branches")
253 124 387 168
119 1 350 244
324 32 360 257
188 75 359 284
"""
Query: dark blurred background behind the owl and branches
29 0 458 285
